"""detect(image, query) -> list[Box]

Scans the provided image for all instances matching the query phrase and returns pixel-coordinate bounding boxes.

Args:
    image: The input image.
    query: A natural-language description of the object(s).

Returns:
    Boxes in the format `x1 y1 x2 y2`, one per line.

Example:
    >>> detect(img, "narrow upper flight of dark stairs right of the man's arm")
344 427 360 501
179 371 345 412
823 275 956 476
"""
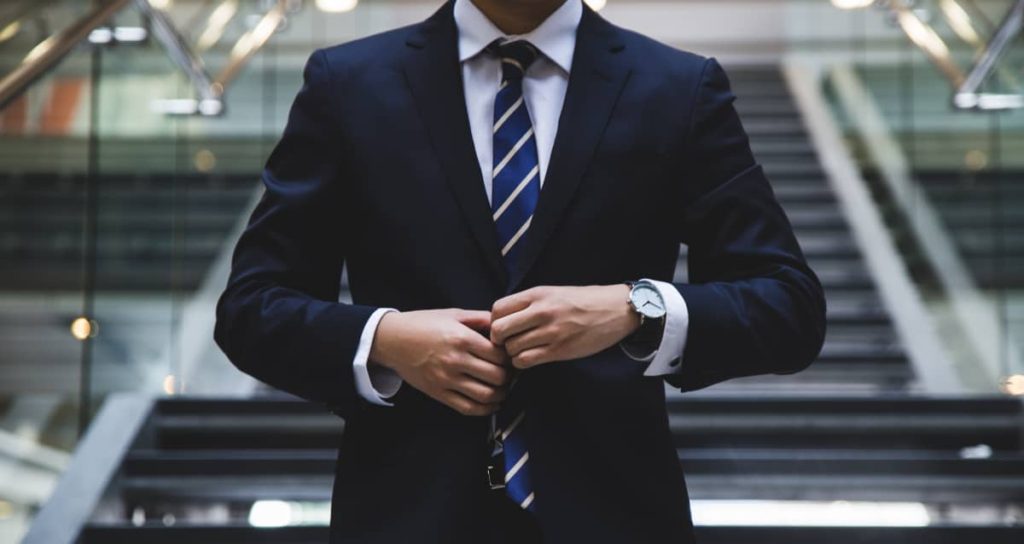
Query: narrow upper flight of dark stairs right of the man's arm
677 67 914 395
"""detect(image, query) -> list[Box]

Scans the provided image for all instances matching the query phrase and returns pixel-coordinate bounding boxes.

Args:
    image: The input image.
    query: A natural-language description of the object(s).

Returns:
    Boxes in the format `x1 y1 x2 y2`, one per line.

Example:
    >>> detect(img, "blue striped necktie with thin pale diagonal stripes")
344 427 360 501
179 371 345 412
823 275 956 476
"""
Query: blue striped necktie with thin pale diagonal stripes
488 40 541 511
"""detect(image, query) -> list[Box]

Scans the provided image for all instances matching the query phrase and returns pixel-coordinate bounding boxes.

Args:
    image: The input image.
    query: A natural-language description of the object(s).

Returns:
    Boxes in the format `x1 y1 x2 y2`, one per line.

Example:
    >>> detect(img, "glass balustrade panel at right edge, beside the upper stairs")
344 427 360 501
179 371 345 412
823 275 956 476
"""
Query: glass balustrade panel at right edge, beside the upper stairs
806 0 1024 387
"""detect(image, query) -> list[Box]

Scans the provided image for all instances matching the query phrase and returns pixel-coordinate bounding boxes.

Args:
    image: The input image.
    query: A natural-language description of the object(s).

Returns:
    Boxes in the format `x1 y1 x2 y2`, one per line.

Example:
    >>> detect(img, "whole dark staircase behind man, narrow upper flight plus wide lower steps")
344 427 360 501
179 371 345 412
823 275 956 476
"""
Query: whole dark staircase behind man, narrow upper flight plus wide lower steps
26 67 1024 544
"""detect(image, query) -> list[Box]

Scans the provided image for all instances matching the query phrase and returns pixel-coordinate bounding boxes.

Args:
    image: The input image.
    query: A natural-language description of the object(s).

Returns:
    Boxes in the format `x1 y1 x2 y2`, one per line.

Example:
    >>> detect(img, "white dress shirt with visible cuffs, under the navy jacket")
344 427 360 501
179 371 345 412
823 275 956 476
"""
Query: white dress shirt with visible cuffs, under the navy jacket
353 0 689 406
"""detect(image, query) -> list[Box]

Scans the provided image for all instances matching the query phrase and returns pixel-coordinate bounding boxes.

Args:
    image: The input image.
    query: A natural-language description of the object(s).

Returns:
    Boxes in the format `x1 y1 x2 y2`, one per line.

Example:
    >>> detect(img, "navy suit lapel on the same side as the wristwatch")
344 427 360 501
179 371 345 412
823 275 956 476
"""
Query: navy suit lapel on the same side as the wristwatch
505 4 630 292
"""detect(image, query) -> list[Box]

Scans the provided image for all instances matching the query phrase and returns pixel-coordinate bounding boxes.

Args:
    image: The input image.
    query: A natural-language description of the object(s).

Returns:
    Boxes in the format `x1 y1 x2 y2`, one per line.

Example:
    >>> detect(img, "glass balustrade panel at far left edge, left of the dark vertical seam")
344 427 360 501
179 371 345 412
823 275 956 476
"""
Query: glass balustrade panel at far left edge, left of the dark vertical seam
0 1 104 542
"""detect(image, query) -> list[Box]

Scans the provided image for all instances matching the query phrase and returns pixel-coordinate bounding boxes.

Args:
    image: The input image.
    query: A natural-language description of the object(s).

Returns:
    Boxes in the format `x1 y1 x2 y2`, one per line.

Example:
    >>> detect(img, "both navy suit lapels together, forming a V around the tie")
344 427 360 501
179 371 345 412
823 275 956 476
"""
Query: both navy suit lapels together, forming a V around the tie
404 1 630 292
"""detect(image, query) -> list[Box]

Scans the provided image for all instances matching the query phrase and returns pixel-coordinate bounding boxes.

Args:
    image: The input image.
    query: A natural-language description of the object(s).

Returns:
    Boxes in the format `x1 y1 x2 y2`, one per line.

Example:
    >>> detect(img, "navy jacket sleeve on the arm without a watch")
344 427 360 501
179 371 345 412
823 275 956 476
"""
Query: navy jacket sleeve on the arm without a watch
214 50 376 415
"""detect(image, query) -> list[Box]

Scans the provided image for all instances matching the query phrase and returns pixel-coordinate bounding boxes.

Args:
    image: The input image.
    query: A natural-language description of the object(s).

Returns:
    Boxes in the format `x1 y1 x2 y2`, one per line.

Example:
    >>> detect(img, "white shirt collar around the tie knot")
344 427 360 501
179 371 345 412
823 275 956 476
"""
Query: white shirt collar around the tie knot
454 0 583 73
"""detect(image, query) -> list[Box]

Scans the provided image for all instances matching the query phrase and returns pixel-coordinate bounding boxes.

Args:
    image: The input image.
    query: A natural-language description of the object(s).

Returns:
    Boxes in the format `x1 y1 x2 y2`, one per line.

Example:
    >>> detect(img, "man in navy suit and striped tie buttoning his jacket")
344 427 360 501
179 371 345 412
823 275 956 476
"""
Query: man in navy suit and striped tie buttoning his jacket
215 0 824 543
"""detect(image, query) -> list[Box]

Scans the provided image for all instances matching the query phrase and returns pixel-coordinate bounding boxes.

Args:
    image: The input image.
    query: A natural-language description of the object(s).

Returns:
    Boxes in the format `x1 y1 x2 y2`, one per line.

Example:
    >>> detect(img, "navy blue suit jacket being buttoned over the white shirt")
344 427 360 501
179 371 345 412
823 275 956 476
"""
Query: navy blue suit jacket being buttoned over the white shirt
215 2 824 544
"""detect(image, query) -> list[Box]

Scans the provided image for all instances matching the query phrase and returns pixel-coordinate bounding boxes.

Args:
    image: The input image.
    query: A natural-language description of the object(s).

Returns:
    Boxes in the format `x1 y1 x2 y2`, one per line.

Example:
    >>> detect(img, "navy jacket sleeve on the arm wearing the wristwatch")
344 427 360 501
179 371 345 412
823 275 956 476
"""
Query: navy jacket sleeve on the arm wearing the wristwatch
666 58 825 391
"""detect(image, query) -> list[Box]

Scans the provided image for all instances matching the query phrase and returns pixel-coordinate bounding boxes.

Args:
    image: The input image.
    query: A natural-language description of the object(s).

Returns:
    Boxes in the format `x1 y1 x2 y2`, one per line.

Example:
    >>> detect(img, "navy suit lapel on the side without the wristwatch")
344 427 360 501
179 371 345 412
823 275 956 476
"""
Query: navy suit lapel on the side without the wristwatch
404 2 507 285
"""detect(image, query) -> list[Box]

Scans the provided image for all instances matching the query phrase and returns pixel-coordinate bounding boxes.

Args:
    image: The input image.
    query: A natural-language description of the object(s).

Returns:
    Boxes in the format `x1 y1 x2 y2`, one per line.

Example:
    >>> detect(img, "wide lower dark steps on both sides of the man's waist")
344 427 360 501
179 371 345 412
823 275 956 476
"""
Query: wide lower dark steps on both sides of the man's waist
26 395 1024 544
